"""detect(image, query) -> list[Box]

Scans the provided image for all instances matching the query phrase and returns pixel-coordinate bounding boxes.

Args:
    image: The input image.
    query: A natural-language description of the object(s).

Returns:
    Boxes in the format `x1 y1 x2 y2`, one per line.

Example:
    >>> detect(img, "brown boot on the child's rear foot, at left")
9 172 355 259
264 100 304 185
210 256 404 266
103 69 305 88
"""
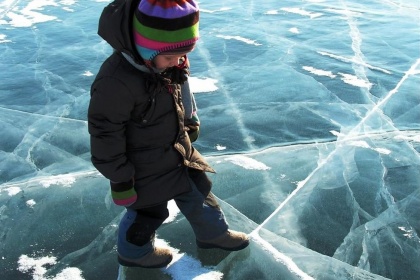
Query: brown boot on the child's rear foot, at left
118 247 172 268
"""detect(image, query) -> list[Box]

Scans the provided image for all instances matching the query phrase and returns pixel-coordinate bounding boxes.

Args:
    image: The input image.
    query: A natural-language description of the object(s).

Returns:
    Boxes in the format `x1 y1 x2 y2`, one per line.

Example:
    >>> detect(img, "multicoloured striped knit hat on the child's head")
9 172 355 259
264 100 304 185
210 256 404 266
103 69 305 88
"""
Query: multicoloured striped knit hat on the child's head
133 0 199 64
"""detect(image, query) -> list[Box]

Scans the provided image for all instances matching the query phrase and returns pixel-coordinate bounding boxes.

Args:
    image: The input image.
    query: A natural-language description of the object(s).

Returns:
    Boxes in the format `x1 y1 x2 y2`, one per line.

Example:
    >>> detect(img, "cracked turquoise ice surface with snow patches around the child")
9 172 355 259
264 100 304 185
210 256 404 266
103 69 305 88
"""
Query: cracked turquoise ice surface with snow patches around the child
0 0 420 280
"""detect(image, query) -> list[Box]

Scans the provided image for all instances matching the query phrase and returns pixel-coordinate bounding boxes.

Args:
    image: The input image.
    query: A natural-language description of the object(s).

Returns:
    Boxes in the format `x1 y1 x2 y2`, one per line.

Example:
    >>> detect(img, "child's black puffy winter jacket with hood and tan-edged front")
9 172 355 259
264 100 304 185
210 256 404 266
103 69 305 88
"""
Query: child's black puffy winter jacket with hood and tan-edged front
88 0 214 209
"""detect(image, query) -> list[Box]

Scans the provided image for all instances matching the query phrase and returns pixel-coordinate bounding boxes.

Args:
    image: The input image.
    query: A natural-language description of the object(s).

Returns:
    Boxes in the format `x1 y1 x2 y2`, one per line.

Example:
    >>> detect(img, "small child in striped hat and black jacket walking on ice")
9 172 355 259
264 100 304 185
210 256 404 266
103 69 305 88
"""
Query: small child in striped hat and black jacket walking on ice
88 0 249 268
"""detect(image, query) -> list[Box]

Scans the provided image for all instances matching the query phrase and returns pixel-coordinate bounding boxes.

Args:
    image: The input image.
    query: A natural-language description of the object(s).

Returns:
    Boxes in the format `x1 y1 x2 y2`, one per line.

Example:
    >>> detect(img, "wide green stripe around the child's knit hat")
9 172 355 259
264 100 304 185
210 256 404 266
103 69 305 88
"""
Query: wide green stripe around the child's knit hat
134 19 199 43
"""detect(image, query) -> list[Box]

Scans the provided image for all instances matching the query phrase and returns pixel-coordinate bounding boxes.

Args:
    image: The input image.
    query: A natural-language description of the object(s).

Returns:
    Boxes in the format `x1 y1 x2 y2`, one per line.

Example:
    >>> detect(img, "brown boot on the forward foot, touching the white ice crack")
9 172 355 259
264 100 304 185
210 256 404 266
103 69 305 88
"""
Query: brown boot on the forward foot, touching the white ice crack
196 230 249 251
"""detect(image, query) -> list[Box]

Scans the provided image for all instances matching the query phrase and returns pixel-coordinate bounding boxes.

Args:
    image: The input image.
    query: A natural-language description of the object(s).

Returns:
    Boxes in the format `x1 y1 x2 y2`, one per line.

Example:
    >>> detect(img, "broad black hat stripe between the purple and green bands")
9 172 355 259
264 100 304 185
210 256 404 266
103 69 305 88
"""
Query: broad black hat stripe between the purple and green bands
134 10 199 31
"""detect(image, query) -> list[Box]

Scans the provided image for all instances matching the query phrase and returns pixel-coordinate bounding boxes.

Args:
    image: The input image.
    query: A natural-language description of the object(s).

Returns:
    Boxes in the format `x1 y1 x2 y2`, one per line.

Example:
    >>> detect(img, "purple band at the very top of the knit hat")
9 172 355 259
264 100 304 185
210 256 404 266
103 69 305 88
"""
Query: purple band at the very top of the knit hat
137 0 198 19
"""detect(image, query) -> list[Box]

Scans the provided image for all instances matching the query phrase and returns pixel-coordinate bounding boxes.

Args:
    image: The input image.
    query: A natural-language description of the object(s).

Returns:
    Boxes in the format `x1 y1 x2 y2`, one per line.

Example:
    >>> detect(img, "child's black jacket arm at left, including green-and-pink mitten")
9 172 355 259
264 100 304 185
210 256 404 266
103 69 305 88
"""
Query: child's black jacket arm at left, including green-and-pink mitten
88 79 137 206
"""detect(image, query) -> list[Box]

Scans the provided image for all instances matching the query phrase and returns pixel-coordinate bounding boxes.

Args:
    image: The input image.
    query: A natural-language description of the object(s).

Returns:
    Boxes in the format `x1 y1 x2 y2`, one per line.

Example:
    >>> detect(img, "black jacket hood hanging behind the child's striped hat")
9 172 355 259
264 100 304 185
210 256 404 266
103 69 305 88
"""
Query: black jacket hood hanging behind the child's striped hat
98 0 144 64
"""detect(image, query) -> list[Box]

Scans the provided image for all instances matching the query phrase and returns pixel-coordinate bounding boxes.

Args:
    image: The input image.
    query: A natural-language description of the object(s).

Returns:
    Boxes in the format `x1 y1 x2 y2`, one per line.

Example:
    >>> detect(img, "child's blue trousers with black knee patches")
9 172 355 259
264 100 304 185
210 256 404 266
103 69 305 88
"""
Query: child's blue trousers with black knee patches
118 170 228 258
